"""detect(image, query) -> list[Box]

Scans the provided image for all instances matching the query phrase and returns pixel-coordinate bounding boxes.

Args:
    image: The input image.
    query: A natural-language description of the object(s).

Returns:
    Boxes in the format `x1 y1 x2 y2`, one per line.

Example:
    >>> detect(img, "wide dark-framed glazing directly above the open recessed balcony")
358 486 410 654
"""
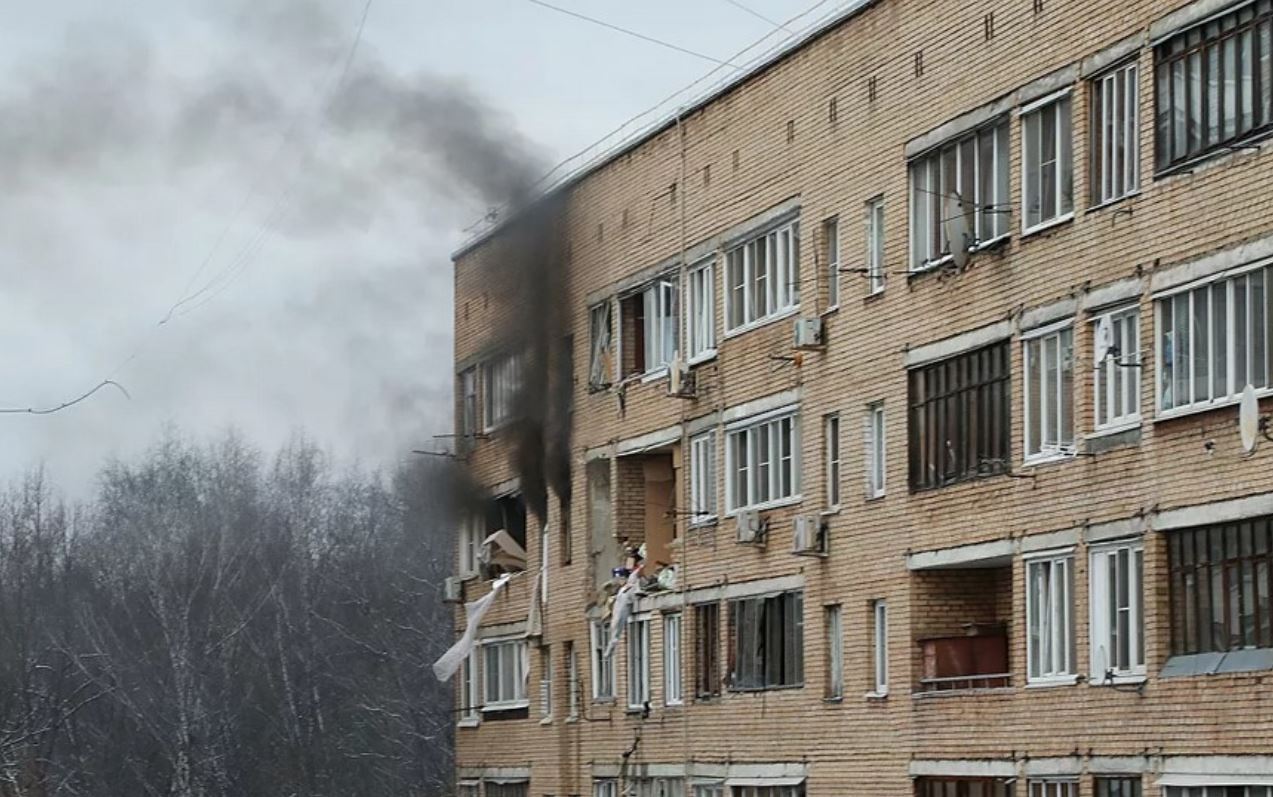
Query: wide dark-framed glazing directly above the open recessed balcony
908 341 1011 490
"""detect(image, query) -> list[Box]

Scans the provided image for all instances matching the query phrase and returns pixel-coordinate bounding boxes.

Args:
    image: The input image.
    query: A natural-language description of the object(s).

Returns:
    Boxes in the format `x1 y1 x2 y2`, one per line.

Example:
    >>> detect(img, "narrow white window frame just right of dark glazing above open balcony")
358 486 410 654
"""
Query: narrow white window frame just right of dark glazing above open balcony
1021 320 1076 462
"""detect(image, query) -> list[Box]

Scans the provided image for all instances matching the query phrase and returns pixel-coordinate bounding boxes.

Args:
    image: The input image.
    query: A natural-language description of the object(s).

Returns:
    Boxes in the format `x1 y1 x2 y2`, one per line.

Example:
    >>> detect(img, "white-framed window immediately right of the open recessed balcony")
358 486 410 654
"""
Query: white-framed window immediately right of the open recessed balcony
1026 554 1074 681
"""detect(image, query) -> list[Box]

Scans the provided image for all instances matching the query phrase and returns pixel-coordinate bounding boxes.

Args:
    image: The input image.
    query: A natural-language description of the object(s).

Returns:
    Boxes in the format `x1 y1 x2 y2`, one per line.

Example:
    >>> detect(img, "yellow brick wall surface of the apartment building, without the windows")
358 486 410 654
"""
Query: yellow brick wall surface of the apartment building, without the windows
456 0 1273 797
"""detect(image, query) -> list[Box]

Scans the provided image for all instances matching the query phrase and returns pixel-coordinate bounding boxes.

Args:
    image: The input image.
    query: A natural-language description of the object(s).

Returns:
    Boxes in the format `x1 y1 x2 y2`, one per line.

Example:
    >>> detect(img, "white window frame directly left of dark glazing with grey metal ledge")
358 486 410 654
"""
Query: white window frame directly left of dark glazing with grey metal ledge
1087 540 1146 684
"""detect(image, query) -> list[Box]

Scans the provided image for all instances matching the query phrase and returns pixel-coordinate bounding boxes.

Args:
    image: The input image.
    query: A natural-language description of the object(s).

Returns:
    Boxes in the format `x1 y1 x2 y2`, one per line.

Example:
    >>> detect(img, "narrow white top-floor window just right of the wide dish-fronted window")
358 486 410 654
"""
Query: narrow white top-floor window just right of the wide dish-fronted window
1021 93 1074 230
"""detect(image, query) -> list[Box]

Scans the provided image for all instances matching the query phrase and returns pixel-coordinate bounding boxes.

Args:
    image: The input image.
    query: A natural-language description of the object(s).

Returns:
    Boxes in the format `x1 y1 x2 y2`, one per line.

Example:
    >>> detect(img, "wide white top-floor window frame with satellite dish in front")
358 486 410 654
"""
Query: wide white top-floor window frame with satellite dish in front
908 113 1012 271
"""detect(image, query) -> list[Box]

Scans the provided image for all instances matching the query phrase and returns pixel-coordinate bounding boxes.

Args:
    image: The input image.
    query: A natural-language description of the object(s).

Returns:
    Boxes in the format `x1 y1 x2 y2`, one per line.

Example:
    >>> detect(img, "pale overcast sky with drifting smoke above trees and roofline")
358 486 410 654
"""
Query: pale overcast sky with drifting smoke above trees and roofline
0 0 844 494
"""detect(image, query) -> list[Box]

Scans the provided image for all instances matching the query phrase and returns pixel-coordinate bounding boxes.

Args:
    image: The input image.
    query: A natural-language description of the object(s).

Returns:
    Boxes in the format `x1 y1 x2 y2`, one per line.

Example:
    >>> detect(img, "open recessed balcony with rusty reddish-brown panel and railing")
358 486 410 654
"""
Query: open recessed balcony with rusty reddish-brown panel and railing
911 556 1013 694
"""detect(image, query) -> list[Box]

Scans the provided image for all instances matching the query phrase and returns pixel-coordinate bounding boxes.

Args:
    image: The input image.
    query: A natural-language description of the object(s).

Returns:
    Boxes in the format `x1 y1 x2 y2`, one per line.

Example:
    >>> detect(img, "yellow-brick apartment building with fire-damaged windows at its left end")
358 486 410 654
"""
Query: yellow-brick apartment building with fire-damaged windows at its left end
451 0 1273 797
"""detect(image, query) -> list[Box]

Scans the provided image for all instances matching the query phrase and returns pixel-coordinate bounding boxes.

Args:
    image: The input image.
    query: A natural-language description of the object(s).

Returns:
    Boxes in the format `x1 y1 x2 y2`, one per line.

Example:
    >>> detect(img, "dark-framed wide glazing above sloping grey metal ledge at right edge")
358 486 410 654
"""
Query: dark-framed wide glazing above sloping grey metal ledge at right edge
1167 517 1273 656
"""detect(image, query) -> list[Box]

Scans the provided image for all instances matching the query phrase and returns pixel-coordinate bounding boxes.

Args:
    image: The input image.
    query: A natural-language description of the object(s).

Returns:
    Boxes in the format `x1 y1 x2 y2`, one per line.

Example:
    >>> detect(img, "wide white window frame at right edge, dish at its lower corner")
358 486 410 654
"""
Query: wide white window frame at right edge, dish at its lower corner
1153 261 1273 418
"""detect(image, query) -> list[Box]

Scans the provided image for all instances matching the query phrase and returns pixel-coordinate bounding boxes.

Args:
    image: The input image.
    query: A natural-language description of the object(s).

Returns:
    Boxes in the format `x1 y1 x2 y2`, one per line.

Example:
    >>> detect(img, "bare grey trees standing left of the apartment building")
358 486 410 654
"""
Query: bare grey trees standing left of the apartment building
0 434 453 797
